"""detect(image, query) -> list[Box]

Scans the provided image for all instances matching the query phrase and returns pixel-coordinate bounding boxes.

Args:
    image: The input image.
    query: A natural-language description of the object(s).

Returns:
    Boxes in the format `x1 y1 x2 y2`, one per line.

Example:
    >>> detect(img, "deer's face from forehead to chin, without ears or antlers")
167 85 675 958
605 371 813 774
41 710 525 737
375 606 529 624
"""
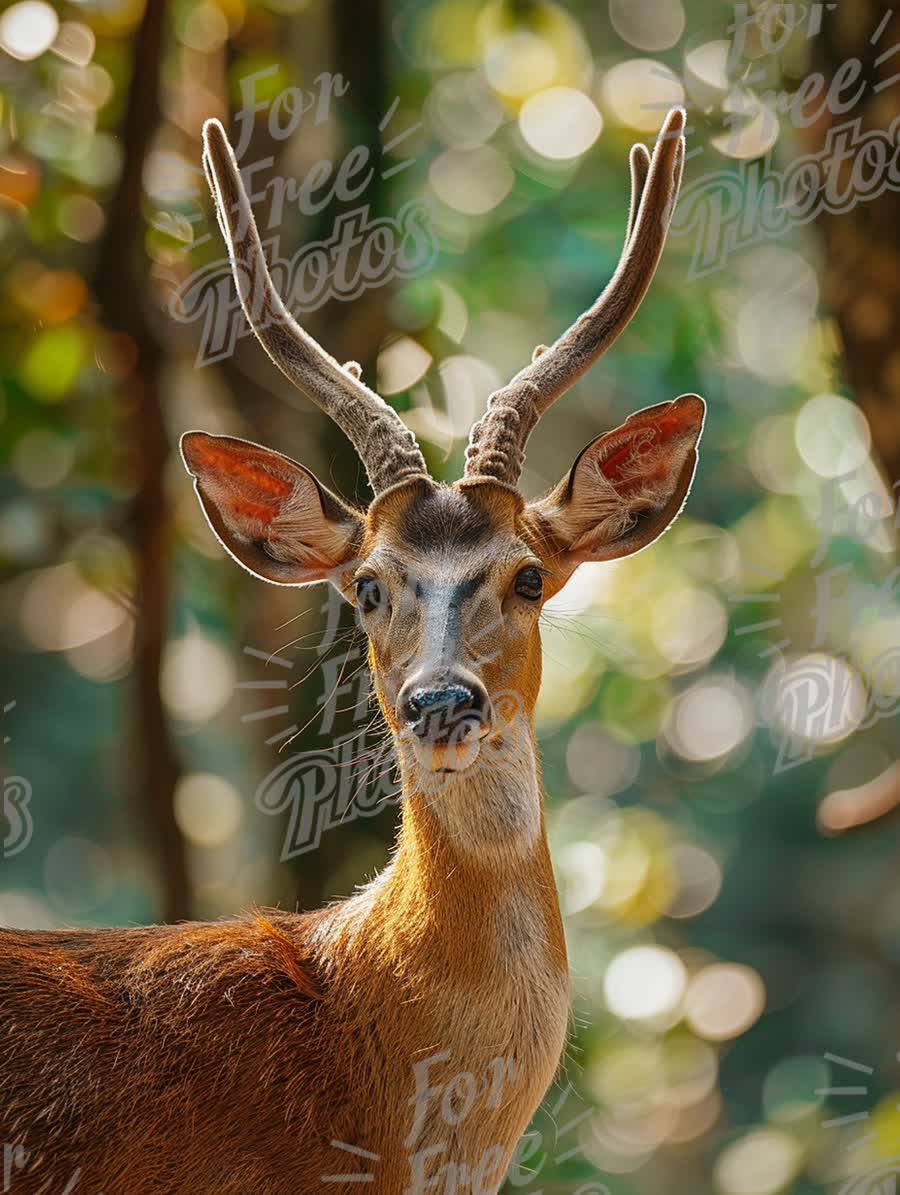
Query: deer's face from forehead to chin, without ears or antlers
354 482 545 772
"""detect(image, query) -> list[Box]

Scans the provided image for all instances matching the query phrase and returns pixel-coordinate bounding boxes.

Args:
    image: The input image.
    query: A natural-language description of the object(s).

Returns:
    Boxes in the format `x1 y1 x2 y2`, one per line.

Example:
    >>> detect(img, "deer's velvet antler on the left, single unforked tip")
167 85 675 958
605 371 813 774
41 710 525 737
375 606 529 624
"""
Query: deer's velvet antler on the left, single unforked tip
203 121 428 494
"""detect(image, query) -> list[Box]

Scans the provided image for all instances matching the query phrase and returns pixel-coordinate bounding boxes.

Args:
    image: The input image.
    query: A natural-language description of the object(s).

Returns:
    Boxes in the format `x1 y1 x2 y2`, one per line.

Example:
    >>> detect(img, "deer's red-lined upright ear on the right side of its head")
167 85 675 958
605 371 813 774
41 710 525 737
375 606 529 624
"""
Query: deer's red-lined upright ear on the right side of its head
529 394 706 571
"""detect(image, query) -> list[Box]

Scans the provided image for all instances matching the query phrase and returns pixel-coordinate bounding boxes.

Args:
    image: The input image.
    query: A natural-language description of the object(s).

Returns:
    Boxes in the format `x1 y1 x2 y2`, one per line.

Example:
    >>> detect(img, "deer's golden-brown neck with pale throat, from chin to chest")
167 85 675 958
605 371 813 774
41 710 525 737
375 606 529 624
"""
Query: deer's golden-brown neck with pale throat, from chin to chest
334 723 567 992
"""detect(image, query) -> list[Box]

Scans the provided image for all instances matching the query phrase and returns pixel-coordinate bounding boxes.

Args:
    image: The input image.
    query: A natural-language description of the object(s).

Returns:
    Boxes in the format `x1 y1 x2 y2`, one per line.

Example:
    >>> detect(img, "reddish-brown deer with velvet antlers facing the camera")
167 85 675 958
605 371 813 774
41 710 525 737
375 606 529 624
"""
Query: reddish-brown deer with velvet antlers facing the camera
0 109 705 1195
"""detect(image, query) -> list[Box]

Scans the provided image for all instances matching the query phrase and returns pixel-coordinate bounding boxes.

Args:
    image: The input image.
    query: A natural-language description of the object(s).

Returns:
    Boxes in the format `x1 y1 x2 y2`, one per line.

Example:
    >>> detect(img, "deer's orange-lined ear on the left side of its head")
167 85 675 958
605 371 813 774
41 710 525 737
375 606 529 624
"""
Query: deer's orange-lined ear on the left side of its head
182 431 363 586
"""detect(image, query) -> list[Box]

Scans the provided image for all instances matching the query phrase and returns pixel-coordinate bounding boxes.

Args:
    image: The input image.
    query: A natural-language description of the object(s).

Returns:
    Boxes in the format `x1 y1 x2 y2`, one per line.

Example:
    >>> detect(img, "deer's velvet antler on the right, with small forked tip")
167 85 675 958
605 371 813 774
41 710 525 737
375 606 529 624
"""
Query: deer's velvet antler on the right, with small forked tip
465 108 685 485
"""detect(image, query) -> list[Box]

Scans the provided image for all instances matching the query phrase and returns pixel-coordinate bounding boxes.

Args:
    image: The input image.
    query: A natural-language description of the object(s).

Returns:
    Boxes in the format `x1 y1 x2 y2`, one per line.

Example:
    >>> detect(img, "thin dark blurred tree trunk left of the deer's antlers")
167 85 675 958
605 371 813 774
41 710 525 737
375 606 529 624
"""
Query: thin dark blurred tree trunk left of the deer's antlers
94 0 191 921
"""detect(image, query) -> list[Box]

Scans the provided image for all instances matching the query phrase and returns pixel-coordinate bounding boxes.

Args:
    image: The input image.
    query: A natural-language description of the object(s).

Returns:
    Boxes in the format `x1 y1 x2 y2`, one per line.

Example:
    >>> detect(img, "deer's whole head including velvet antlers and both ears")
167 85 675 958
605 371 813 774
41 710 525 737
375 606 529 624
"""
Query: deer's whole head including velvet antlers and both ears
182 109 705 777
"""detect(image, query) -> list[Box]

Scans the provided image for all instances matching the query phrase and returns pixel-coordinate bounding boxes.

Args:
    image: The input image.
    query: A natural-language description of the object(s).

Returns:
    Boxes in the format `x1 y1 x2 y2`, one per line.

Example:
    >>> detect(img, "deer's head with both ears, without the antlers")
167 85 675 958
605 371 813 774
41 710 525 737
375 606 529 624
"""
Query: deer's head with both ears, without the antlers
183 396 704 772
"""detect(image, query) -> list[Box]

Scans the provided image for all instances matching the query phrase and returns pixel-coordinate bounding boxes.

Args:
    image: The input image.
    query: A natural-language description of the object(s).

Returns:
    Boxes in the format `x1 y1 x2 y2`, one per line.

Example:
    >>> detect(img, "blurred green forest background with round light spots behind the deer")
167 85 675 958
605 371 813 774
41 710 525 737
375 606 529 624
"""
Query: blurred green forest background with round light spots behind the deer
0 0 900 1195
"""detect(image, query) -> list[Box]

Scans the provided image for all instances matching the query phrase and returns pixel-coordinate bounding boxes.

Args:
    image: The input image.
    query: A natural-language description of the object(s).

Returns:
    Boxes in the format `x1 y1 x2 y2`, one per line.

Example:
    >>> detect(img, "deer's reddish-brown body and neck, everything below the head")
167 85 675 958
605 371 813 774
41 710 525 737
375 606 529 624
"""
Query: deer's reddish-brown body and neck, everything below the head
0 659 568 1195
